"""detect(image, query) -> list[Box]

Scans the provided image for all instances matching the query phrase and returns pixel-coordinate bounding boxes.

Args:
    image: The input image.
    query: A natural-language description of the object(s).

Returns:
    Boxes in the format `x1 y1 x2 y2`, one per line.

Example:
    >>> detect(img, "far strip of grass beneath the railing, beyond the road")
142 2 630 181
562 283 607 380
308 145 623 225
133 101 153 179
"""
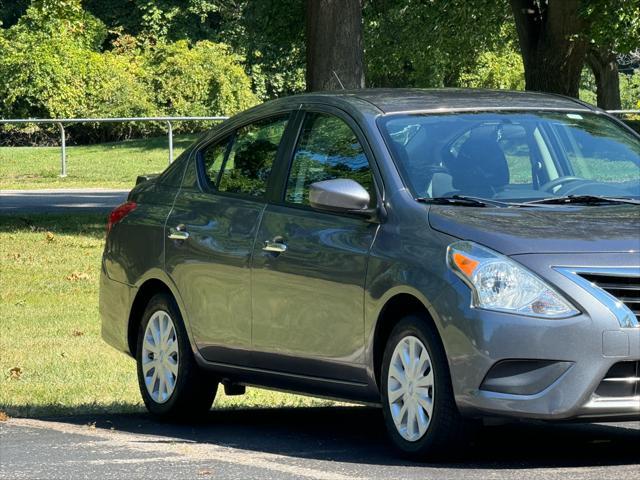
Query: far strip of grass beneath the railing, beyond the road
0 135 198 190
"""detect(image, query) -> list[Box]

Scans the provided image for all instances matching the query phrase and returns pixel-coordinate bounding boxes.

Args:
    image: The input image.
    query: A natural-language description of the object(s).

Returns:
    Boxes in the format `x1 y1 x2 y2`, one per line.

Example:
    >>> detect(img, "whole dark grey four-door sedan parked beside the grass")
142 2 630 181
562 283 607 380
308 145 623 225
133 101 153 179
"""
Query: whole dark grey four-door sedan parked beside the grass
100 90 640 457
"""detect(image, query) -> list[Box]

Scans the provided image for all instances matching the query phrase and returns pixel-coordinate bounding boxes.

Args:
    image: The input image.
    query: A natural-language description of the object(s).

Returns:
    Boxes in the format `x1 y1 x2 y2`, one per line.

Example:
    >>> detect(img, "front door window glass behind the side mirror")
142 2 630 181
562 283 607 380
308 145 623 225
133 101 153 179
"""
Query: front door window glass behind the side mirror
285 113 375 205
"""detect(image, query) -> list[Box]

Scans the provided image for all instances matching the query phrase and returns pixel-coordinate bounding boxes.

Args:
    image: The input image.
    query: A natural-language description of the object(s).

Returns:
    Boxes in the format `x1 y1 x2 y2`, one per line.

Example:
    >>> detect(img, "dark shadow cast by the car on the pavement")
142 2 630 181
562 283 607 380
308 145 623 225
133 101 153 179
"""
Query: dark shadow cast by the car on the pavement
36 406 640 469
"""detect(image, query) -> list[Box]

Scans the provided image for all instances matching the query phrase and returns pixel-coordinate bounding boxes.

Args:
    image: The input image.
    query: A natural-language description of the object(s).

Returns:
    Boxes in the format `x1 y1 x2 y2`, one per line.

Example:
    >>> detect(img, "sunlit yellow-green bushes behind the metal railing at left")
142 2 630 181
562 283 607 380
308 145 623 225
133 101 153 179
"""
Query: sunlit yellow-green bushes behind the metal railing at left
0 0 256 140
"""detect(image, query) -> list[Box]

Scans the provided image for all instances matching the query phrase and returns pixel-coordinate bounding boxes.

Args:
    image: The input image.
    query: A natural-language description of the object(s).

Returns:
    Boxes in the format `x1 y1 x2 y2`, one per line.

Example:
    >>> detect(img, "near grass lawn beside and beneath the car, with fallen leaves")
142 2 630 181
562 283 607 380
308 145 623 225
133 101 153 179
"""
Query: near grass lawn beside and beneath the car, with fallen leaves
0 215 332 416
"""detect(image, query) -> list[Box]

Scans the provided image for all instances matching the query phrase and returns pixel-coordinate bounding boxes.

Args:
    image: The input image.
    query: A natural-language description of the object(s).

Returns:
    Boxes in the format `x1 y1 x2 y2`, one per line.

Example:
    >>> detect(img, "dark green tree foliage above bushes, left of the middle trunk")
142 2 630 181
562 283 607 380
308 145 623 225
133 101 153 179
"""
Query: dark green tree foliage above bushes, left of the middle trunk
85 0 305 100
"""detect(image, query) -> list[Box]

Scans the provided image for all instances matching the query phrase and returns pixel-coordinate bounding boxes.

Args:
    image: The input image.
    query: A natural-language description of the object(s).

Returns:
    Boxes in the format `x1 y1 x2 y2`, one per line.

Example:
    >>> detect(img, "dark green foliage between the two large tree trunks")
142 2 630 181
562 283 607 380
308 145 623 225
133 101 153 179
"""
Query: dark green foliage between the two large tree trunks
364 0 512 87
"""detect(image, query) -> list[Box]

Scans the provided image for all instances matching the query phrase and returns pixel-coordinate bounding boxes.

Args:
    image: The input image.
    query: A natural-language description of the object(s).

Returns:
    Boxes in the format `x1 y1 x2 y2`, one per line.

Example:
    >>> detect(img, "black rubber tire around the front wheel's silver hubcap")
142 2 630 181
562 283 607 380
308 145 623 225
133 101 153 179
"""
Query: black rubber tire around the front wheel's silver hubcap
380 315 469 461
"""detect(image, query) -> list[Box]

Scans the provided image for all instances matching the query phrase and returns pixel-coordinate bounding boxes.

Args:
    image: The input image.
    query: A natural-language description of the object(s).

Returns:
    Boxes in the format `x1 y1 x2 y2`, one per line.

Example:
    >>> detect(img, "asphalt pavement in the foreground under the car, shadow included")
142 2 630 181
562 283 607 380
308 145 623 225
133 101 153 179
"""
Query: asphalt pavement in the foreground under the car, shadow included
0 407 640 480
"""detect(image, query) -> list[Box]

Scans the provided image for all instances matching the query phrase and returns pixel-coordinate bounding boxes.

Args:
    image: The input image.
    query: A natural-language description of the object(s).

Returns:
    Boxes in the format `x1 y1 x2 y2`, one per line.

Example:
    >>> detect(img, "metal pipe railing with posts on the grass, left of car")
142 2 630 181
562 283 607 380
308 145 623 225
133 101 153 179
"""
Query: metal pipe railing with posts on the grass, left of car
0 116 229 177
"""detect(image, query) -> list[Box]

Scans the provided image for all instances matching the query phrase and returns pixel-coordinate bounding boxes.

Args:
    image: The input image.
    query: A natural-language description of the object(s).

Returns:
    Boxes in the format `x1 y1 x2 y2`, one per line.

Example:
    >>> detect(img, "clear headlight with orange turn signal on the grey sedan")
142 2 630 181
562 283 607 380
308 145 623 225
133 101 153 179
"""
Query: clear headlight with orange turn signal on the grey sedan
447 242 579 318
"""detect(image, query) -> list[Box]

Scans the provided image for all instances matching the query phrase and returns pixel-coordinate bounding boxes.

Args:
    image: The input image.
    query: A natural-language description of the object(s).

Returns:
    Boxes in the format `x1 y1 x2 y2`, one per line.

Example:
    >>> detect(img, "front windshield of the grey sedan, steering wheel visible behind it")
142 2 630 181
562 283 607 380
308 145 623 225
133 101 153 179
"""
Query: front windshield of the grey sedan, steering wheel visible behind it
379 112 640 201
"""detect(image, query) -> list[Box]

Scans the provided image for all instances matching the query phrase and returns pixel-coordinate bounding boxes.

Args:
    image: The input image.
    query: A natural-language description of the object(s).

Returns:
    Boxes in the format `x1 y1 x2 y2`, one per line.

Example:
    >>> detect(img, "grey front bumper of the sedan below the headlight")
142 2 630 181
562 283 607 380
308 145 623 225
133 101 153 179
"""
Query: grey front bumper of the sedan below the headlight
440 254 640 420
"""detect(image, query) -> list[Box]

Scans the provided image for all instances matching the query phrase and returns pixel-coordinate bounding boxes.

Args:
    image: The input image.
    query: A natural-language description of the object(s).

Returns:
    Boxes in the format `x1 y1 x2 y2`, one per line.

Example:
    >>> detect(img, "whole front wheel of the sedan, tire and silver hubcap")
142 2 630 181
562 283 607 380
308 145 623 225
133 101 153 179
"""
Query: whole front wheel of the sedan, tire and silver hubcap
380 315 466 460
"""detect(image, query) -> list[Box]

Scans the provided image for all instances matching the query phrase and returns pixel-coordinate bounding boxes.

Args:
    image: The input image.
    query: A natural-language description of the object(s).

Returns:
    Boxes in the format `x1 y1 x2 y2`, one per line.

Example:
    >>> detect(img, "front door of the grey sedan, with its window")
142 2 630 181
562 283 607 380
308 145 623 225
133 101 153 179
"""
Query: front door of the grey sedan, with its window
252 113 377 381
